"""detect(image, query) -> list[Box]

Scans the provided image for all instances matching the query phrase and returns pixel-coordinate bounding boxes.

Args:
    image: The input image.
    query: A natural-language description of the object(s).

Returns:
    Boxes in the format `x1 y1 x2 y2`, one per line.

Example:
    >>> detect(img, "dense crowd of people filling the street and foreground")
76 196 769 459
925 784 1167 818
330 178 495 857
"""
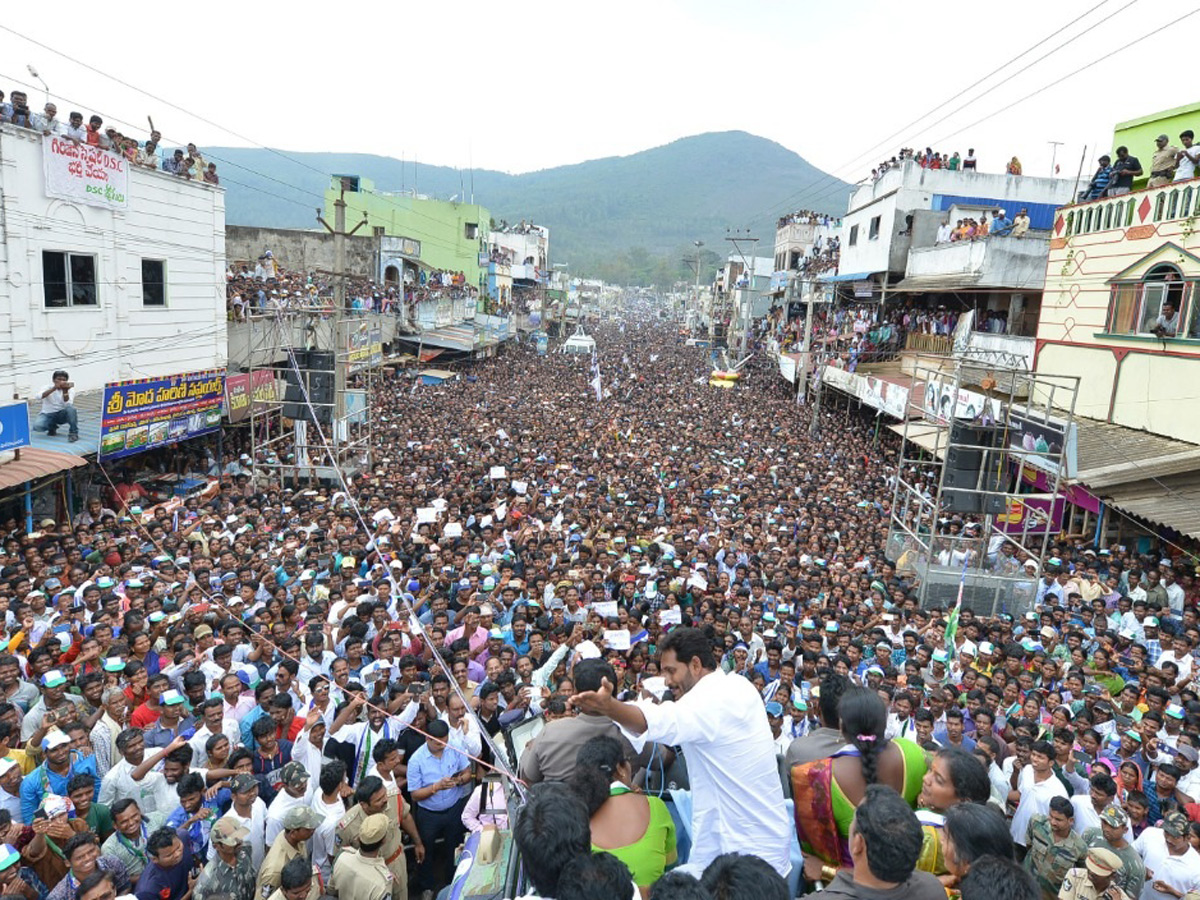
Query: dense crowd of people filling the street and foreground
0 305 1200 900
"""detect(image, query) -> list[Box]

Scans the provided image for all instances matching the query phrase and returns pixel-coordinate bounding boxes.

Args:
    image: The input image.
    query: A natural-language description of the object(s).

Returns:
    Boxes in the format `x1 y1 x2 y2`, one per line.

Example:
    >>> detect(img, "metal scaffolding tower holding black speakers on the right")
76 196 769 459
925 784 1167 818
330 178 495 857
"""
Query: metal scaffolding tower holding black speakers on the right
888 350 1080 617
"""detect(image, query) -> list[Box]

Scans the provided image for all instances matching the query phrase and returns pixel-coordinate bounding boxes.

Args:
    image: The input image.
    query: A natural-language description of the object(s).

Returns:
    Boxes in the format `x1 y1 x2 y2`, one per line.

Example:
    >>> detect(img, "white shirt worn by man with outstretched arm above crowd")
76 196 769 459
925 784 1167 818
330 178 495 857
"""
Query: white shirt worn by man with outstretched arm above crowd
625 670 792 877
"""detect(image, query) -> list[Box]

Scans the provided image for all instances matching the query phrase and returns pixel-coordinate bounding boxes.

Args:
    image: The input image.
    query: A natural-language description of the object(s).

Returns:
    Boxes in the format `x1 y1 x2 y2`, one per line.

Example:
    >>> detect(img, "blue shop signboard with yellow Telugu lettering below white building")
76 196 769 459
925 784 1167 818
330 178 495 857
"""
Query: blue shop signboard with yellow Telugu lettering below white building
100 368 226 460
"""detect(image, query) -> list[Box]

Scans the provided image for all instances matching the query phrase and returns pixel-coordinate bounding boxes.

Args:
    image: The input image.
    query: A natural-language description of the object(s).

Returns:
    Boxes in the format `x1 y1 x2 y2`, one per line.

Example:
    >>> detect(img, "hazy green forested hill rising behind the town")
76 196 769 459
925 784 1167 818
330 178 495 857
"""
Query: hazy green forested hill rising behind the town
205 131 848 281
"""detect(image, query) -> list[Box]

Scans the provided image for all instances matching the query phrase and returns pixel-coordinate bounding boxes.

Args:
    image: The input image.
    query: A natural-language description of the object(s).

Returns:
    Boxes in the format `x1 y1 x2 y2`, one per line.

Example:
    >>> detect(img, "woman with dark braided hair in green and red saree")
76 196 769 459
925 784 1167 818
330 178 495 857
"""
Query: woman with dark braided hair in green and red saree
791 676 925 868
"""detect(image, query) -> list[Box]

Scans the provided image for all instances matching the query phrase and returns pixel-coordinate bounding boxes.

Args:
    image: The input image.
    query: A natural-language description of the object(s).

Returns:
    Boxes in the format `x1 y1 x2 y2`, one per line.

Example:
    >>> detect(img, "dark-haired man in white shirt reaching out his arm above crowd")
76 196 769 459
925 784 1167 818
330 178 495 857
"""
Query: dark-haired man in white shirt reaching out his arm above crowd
571 628 792 877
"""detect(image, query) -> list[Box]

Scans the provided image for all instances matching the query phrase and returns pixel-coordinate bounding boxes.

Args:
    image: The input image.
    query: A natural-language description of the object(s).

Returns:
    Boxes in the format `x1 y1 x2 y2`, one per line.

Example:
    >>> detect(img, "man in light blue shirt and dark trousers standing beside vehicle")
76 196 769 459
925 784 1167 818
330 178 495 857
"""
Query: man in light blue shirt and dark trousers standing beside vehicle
408 719 470 893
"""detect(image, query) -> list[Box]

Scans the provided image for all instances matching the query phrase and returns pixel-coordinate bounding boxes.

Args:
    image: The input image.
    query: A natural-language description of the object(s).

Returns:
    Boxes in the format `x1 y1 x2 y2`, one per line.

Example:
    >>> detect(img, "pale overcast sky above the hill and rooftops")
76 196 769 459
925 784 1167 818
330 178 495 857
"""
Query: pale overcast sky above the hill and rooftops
0 0 1200 207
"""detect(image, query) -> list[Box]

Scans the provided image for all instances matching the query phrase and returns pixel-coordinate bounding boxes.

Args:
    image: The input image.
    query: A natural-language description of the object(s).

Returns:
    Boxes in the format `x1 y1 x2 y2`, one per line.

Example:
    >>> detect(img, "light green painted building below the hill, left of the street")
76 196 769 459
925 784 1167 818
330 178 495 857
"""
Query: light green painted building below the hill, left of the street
325 175 491 294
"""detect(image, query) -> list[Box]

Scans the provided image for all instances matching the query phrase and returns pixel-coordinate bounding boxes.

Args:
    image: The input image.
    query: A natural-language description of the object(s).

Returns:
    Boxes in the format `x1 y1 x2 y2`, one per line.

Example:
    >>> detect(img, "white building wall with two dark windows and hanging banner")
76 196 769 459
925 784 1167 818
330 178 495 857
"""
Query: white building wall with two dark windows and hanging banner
0 125 228 400
